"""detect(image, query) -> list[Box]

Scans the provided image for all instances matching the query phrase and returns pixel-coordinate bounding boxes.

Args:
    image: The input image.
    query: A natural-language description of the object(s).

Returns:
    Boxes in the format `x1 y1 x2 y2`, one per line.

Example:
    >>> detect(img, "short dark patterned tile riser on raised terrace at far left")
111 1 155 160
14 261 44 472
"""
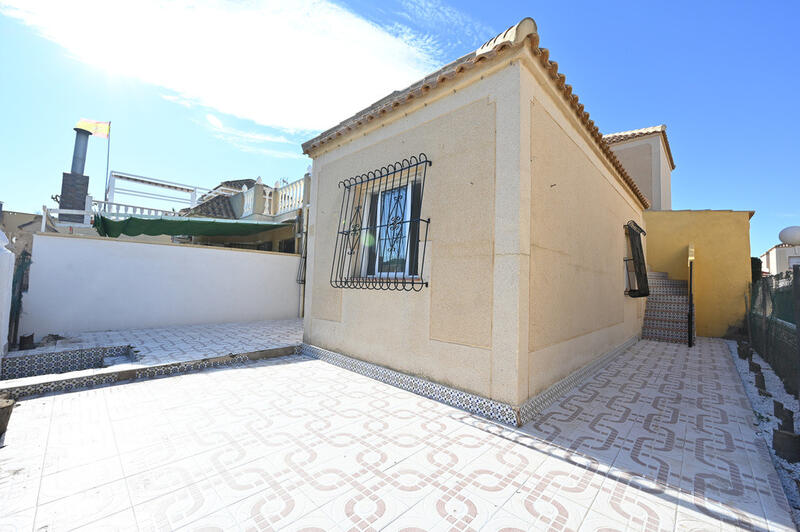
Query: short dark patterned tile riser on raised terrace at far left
0 345 132 380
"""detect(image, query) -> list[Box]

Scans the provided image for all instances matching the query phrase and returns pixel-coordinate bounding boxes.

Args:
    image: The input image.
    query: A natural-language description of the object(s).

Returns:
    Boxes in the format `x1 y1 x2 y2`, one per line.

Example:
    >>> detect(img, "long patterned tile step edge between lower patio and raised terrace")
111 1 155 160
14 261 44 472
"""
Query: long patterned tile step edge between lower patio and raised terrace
0 346 296 399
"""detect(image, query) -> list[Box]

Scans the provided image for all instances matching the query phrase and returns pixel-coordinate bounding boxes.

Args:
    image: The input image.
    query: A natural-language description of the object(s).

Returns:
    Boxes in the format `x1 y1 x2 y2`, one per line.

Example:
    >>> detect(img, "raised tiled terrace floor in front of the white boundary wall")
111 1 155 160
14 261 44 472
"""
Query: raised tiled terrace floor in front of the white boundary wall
0 318 303 389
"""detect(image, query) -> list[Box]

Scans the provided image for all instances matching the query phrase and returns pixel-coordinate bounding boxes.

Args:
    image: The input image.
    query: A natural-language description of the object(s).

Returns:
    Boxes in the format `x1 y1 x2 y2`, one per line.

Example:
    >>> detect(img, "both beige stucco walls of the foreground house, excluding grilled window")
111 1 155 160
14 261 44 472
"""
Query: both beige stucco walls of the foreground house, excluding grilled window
304 45 643 405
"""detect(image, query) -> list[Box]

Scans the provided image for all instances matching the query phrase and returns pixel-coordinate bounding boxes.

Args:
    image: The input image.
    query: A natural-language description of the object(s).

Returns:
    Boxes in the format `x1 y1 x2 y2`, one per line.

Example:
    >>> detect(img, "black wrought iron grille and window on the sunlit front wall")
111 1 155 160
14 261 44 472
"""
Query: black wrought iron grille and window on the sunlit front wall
331 153 433 292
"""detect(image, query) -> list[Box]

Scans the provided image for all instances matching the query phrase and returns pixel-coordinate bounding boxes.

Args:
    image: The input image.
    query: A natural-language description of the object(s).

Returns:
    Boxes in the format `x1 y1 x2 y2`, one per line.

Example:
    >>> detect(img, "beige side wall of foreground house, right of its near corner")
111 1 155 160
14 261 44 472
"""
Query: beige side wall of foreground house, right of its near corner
523 54 649 397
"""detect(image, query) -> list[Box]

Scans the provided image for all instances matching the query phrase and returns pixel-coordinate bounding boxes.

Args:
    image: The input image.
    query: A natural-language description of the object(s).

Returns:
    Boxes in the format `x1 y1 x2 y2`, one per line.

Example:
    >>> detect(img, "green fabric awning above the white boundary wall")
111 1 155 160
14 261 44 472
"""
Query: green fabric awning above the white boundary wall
92 214 292 238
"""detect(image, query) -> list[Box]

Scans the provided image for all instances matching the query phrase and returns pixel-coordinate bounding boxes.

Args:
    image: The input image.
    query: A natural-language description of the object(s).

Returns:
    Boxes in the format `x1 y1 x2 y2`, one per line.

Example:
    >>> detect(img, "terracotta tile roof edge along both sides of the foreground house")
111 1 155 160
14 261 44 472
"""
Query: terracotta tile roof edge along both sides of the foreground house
303 18 650 208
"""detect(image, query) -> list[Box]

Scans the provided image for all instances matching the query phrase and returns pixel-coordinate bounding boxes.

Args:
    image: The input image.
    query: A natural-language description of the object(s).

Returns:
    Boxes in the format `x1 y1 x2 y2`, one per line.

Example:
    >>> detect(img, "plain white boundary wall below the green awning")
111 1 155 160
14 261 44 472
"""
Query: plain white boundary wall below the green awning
20 234 300 341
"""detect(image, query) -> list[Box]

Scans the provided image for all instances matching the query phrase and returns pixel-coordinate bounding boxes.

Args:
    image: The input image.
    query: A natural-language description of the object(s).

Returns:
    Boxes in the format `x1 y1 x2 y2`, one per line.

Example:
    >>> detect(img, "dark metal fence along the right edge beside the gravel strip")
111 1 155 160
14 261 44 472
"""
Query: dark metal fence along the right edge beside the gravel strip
748 267 800 397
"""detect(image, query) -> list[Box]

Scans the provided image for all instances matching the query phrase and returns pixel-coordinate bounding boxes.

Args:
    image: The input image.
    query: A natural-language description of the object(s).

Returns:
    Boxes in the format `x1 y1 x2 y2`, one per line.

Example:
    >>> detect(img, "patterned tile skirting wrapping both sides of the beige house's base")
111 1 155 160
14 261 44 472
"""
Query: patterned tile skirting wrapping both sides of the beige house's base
297 337 639 427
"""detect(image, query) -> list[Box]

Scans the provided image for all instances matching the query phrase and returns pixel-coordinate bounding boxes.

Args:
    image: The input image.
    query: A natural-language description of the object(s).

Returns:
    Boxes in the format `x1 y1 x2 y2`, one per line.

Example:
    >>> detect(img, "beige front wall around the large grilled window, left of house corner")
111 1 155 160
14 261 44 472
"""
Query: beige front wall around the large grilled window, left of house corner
305 57 520 401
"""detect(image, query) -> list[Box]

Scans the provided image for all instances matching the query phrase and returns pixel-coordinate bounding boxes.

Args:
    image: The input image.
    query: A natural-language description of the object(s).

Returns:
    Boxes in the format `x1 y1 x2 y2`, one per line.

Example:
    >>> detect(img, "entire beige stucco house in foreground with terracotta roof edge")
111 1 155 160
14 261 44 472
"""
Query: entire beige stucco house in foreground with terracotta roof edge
303 18 650 422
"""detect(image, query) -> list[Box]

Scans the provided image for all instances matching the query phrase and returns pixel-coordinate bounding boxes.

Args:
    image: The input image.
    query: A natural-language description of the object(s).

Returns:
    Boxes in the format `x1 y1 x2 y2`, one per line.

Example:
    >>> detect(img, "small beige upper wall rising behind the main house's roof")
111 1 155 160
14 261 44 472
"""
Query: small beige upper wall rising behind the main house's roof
611 133 672 211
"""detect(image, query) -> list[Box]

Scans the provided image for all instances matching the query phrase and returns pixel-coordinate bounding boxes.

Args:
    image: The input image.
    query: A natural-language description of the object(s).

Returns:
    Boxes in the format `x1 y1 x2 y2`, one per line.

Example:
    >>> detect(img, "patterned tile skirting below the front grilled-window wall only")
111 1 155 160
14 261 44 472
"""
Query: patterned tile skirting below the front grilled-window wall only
298 344 518 425
